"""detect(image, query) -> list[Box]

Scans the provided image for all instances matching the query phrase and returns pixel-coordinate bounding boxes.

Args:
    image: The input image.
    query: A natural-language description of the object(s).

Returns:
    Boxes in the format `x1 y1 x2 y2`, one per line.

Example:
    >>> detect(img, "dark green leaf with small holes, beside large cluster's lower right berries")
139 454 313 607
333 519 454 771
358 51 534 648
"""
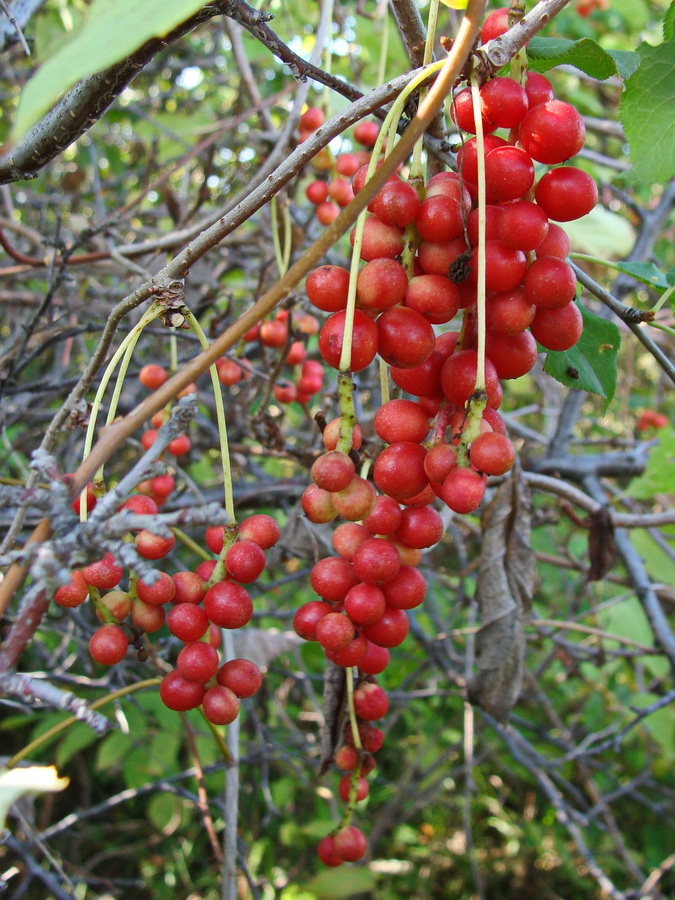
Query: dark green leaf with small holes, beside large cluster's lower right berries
544 303 621 411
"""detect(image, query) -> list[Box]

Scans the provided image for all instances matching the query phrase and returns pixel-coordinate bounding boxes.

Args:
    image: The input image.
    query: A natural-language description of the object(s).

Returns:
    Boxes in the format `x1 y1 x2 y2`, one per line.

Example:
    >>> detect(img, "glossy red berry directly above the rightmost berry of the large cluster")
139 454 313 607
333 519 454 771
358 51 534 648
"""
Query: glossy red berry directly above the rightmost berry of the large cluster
519 100 586 166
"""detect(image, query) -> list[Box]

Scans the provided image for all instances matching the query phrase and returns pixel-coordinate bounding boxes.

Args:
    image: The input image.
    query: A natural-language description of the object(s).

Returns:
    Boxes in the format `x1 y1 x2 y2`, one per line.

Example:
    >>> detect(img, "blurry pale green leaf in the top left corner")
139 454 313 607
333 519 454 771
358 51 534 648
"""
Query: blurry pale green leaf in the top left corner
12 0 204 141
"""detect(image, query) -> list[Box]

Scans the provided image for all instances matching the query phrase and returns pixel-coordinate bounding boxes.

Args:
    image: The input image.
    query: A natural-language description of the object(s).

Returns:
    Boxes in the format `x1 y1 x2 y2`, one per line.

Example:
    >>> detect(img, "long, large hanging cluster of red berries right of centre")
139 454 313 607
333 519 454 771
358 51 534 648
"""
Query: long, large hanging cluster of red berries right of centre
294 9 597 865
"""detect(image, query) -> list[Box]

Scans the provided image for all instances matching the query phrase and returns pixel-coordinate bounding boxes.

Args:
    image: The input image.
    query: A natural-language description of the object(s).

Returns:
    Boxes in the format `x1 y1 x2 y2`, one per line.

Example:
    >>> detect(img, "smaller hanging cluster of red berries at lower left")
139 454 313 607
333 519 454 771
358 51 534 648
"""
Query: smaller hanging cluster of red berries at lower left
54 506 279 725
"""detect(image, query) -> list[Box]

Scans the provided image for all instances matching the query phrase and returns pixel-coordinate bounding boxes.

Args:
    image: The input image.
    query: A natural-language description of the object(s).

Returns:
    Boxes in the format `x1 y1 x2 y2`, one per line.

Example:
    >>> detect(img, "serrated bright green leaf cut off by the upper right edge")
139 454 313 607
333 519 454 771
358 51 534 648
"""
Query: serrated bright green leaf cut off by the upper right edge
620 37 675 184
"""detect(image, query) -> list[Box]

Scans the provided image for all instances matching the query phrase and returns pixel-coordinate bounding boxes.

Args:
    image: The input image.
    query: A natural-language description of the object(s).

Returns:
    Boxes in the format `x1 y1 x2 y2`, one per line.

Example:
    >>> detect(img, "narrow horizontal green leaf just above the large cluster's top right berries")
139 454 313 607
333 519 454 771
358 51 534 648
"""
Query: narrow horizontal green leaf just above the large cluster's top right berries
527 37 640 81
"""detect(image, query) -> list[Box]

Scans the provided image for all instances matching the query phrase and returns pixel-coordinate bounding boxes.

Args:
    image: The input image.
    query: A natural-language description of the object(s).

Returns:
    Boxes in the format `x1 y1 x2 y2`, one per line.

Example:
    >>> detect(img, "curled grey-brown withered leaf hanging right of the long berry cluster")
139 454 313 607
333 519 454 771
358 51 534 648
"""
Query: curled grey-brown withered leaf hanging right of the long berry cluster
468 469 535 722
